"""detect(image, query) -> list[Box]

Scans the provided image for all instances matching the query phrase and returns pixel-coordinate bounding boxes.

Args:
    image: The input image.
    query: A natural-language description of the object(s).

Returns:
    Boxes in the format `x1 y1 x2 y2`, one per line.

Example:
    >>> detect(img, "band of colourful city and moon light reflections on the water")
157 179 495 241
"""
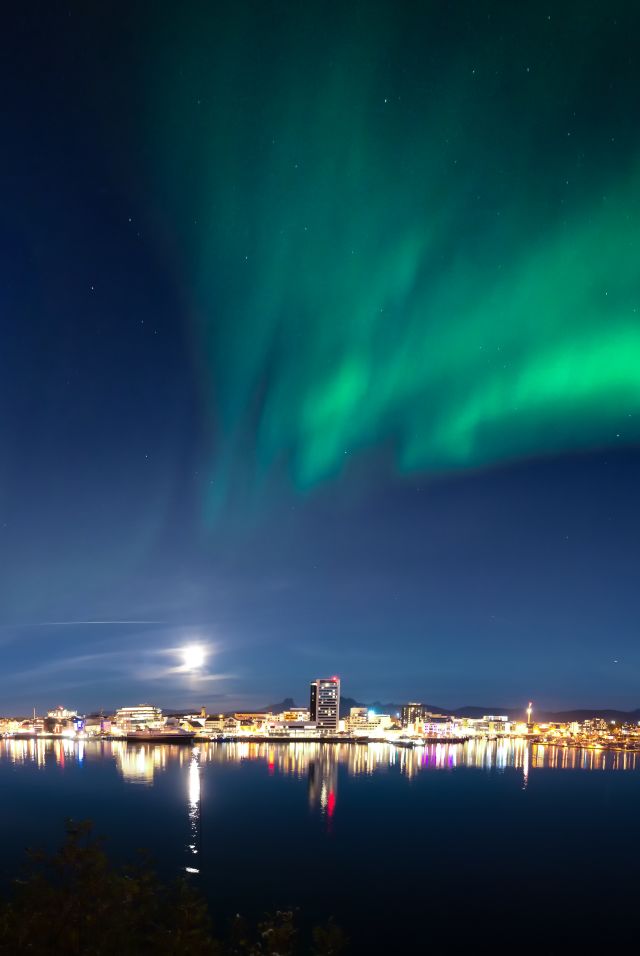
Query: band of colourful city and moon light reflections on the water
0 738 640 878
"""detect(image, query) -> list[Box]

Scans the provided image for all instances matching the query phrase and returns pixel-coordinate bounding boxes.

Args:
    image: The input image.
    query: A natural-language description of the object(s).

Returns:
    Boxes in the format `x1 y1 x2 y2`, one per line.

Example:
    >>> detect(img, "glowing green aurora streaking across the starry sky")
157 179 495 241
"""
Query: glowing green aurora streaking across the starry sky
148 2 640 516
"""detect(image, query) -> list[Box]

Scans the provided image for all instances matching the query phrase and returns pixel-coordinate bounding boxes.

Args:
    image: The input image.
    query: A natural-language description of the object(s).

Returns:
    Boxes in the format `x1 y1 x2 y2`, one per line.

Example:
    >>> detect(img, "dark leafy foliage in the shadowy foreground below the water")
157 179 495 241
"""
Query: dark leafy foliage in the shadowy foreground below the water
0 823 344 956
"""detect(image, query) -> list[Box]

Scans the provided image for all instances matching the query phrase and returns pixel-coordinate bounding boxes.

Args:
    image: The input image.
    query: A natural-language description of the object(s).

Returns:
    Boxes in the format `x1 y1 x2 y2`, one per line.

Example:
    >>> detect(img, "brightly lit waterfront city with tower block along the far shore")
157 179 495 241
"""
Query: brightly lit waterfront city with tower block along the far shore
0 676 640 753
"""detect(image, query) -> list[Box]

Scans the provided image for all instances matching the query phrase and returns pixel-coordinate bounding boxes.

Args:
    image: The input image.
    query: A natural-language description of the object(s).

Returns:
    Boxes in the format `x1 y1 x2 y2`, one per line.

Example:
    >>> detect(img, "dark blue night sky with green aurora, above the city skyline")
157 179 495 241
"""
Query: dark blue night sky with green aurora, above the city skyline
0 0 640 712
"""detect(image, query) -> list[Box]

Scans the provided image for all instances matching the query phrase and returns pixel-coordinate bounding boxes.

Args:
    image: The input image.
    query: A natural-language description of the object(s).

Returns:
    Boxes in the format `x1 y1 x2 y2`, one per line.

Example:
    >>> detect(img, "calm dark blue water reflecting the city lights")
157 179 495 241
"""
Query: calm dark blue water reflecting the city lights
0 740 640 953
